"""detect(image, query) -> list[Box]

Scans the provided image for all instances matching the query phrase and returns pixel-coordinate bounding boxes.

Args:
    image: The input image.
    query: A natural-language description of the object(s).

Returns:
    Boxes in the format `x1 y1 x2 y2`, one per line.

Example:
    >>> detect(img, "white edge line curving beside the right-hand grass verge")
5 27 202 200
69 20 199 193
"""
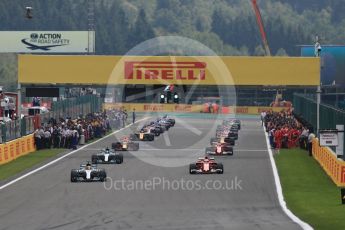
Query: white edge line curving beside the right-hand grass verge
263 128 313 230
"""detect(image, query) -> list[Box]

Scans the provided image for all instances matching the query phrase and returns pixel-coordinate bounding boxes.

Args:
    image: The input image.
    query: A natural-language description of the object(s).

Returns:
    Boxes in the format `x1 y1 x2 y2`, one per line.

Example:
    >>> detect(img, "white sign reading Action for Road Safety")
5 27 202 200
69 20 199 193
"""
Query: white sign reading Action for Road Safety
0 31 94 53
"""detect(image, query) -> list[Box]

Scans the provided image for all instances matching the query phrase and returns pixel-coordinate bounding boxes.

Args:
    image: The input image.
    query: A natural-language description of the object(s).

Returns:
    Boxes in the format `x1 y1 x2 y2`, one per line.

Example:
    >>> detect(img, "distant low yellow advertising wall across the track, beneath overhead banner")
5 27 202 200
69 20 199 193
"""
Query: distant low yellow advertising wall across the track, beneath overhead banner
103 103 288 115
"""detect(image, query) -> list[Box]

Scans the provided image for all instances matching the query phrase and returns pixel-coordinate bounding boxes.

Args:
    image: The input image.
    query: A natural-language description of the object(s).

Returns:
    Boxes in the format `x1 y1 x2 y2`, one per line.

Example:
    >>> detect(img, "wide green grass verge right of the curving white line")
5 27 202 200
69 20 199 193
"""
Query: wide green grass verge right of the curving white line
275 149 345 230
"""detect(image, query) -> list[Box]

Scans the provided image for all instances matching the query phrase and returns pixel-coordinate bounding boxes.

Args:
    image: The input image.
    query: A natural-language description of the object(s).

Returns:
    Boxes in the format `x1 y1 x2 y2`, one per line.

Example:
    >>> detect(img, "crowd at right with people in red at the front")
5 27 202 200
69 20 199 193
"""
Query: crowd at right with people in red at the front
261 110 315 153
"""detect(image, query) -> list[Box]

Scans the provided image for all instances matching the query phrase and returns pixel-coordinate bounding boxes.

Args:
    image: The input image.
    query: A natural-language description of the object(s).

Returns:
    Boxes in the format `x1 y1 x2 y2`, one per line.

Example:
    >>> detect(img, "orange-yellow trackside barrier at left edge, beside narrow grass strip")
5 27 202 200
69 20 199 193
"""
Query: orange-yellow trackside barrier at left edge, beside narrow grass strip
0 134 36 165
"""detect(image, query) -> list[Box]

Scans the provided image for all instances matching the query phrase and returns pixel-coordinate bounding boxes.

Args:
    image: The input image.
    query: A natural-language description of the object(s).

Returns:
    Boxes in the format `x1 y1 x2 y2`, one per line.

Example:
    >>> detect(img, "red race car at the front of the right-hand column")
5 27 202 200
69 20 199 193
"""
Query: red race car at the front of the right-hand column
189 156 224 174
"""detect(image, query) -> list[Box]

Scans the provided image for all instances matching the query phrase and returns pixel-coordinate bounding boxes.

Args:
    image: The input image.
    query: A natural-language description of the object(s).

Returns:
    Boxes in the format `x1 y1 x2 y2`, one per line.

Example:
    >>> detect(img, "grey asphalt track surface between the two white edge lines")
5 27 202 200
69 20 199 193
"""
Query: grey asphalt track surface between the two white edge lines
0 117 300 230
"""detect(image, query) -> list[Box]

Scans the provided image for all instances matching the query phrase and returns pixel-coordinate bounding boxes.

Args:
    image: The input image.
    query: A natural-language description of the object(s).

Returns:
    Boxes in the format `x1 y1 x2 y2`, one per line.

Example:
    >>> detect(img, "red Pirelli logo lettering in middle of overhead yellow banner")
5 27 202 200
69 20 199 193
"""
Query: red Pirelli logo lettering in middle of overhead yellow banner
125 61 206 81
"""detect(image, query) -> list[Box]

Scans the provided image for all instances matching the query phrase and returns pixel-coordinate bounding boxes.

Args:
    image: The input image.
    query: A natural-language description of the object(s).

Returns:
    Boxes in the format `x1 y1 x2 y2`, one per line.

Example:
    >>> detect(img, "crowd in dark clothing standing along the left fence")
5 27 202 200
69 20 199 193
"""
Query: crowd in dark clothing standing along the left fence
34 109 128 149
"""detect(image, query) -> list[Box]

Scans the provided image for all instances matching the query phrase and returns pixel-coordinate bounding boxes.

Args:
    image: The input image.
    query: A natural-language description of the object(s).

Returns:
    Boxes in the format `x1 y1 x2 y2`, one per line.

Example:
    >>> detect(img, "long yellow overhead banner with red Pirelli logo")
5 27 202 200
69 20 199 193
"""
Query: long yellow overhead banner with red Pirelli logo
18 55 320 86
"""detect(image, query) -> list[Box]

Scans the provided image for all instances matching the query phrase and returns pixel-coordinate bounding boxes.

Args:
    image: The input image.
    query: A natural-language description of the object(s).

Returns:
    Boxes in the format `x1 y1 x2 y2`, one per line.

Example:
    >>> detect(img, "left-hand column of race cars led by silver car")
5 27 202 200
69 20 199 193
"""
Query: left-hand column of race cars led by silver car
71 115 175 182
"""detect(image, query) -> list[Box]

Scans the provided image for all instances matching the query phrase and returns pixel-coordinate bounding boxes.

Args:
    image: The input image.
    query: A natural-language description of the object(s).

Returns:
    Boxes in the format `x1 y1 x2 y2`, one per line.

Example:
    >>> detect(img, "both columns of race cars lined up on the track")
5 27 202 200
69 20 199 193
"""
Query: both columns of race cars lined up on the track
71 115 241 182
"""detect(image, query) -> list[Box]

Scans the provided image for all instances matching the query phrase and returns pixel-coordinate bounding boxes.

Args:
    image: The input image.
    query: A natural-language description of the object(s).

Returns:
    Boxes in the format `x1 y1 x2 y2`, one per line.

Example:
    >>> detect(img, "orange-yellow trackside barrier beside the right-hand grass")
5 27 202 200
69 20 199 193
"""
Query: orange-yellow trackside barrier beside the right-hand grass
313 138 345 187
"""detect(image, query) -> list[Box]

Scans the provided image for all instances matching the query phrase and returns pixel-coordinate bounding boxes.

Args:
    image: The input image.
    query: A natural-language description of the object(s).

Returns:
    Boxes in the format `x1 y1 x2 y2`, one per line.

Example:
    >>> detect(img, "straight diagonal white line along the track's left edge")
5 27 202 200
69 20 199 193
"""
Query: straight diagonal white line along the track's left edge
0 117 148 190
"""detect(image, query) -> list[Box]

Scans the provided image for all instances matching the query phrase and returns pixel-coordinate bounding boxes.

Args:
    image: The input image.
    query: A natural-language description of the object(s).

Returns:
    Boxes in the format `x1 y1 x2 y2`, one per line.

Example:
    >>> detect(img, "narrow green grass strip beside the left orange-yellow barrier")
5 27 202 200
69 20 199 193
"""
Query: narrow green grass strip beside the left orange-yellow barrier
0 149 66 181
